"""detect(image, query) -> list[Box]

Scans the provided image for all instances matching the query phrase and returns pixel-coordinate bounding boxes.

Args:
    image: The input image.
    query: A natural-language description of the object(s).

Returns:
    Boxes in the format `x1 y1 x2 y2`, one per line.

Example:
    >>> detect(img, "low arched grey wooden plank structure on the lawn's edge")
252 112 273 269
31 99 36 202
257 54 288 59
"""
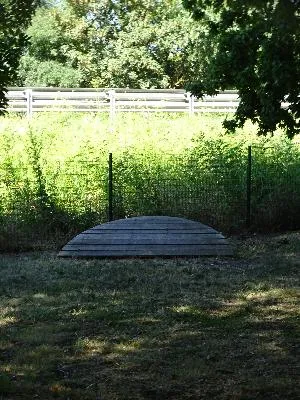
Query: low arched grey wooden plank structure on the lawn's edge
58 216 232 257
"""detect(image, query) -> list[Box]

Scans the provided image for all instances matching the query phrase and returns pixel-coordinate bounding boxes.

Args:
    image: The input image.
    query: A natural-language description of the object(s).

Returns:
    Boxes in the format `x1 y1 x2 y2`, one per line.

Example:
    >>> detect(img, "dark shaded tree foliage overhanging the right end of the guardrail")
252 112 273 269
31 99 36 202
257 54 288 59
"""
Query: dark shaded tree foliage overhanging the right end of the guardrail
183 0 300 137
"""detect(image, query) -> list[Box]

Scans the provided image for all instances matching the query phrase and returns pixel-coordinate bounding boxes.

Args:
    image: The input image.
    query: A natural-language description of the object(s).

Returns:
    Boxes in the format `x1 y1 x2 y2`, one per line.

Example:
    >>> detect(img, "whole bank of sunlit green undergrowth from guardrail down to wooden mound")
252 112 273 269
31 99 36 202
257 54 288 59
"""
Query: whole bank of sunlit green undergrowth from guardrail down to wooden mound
0 113 300 250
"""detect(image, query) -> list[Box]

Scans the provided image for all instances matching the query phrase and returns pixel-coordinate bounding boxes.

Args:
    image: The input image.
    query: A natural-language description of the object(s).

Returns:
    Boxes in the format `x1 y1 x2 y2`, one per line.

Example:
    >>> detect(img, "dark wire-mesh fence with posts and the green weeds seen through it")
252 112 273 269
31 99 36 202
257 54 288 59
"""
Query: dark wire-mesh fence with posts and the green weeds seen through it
0 147 300 250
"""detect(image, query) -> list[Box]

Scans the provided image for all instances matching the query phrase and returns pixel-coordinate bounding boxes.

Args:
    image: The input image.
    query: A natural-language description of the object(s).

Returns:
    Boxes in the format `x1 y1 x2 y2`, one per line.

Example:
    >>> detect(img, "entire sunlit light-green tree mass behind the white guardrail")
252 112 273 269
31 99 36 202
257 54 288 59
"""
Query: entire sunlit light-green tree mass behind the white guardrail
18 0 209 88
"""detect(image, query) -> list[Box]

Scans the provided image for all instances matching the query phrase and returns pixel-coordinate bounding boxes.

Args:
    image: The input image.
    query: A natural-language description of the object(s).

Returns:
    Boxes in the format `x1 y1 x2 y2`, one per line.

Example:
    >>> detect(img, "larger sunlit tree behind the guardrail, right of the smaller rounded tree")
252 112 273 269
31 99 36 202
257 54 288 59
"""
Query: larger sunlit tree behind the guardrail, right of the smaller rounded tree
73 0 209 88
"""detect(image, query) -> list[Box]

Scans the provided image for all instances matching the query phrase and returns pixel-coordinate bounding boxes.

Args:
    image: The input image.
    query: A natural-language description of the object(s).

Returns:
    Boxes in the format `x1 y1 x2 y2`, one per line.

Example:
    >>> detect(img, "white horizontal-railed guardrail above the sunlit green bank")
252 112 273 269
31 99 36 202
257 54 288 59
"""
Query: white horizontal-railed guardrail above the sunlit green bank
7 88 239 116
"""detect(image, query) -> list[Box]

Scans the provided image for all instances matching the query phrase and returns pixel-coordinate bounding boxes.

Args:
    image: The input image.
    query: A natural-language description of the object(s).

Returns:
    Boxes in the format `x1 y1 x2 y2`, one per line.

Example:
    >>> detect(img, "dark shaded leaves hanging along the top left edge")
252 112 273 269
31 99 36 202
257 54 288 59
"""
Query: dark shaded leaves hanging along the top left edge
0 0 39 114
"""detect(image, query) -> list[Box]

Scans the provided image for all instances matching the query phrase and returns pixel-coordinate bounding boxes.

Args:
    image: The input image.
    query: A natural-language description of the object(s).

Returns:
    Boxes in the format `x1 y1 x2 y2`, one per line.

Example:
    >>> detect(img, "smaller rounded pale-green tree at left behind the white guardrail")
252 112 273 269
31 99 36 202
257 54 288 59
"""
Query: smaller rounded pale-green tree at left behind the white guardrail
17 4 87 87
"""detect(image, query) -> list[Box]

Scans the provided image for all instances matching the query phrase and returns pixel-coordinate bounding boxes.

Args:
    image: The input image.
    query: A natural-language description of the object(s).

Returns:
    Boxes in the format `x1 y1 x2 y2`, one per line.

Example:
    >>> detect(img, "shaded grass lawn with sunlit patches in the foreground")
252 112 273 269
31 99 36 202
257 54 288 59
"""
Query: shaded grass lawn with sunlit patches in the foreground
0 232 300 400
